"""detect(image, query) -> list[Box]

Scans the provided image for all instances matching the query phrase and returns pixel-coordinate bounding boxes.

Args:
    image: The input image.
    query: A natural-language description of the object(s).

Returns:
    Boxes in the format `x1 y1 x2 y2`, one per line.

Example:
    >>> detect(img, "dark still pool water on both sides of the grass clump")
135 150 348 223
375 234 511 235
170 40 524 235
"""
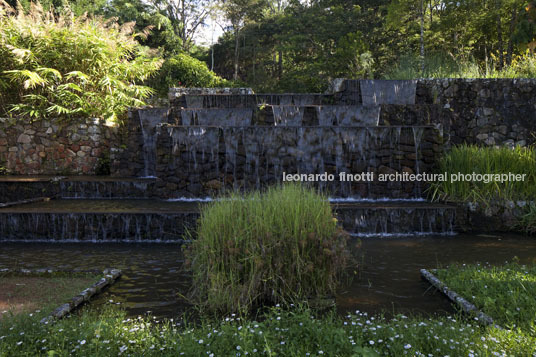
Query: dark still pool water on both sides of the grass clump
0 234 536 317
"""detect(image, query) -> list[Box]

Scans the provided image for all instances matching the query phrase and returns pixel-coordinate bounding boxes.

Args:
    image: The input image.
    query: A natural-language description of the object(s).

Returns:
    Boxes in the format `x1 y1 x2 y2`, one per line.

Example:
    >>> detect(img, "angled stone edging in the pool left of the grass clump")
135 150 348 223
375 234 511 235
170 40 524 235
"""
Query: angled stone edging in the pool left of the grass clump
0 268 122 324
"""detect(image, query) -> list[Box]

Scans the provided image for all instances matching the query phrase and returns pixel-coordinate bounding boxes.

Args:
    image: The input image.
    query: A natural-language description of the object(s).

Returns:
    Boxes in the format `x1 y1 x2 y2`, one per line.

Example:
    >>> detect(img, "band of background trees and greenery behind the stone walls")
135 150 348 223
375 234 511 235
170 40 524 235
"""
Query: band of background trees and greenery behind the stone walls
9 0 536 92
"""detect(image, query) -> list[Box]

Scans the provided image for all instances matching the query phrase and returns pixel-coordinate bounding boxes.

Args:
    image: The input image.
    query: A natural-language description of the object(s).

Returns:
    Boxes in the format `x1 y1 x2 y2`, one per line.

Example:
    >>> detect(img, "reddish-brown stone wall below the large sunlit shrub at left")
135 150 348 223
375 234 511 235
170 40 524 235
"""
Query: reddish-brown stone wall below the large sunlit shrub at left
0 118 119 175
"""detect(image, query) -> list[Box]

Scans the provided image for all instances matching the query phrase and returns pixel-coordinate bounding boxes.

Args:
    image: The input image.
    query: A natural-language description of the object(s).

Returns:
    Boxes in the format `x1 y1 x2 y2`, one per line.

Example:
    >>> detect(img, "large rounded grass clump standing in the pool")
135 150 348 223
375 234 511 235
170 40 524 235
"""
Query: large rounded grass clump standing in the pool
186 185 350 314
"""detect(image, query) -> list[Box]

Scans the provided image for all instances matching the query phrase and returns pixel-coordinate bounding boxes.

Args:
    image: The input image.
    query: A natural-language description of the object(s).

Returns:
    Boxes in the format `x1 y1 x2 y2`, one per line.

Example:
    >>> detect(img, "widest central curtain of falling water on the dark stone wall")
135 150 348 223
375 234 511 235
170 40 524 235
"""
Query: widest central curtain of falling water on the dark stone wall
163 126 434 198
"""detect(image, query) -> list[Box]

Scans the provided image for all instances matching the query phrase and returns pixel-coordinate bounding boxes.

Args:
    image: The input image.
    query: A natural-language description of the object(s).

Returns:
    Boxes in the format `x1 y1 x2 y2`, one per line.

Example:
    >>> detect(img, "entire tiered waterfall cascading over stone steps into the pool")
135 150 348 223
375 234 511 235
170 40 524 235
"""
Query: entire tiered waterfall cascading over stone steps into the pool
0 81 455 241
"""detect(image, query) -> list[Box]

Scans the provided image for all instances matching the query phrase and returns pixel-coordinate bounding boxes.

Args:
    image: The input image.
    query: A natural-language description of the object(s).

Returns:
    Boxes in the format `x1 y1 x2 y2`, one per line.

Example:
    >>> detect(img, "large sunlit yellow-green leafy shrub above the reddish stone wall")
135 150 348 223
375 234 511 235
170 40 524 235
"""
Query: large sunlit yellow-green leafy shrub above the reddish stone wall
0 0 161 121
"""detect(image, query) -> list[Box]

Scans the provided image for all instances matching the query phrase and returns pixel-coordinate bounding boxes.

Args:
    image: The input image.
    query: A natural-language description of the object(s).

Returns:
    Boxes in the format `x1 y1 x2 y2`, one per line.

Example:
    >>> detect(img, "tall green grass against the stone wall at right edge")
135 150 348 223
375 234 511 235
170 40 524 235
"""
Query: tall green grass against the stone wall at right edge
431 145 536 203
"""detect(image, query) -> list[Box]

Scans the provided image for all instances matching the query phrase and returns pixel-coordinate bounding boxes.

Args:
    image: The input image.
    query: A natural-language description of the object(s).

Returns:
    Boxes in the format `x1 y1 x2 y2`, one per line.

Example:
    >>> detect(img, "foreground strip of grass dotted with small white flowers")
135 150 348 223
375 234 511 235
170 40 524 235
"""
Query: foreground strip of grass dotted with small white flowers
0 306 536 356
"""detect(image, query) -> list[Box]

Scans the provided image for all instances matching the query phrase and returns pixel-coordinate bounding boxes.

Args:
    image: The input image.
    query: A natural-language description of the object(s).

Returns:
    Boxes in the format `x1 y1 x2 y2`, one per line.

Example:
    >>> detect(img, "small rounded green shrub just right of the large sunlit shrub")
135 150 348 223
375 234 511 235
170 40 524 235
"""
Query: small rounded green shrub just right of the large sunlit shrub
150 53 230 95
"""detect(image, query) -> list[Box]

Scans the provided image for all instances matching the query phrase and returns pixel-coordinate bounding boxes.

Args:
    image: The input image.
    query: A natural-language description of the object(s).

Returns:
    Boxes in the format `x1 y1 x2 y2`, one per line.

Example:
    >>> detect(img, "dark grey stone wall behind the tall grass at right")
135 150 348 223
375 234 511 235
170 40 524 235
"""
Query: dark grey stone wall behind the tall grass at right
333 79 536 146
